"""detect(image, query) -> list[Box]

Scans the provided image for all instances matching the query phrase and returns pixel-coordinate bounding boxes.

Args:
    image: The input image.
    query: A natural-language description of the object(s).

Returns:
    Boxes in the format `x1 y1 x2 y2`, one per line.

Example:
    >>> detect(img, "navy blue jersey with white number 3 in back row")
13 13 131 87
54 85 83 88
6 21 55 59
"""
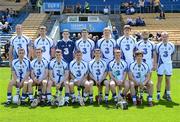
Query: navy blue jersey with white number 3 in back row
56 40 75 64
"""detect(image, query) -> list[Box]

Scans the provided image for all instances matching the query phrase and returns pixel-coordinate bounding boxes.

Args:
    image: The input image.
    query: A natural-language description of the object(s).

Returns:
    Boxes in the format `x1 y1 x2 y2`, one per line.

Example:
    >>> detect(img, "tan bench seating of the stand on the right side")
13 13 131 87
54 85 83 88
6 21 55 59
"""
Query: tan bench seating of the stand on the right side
121 13 180 45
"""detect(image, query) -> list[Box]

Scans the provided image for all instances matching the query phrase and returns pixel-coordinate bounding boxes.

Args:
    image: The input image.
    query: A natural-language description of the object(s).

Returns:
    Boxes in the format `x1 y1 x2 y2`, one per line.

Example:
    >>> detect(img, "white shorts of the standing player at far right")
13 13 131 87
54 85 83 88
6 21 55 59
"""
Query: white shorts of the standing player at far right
157 63 172 76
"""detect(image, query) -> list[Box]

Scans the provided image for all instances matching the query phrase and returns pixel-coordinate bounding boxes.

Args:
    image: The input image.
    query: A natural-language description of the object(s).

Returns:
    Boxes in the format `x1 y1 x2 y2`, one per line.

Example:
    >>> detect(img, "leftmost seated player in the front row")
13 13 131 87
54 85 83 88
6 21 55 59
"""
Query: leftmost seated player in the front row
6 48 30 105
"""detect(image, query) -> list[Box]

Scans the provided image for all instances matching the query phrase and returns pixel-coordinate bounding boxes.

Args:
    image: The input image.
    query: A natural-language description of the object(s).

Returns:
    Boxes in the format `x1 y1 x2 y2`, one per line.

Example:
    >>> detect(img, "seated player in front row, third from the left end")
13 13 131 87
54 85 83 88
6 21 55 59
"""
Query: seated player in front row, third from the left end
47 49 69 105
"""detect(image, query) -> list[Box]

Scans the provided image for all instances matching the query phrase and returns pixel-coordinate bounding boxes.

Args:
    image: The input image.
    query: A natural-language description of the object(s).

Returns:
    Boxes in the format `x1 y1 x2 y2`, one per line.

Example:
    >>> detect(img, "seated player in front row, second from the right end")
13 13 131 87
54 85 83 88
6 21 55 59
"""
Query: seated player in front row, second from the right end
109 50 129 102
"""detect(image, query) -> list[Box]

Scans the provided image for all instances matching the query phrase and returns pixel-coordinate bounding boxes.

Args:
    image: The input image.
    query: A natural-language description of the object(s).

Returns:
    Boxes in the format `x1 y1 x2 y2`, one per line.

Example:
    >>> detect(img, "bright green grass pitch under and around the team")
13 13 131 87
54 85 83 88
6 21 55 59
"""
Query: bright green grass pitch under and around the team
0 68 180 122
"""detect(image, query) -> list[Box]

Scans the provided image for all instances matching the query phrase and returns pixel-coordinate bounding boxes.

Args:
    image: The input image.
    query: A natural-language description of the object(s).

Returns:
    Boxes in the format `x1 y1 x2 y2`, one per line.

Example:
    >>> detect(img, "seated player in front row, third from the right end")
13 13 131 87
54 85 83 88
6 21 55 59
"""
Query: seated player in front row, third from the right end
89 49 109 103
